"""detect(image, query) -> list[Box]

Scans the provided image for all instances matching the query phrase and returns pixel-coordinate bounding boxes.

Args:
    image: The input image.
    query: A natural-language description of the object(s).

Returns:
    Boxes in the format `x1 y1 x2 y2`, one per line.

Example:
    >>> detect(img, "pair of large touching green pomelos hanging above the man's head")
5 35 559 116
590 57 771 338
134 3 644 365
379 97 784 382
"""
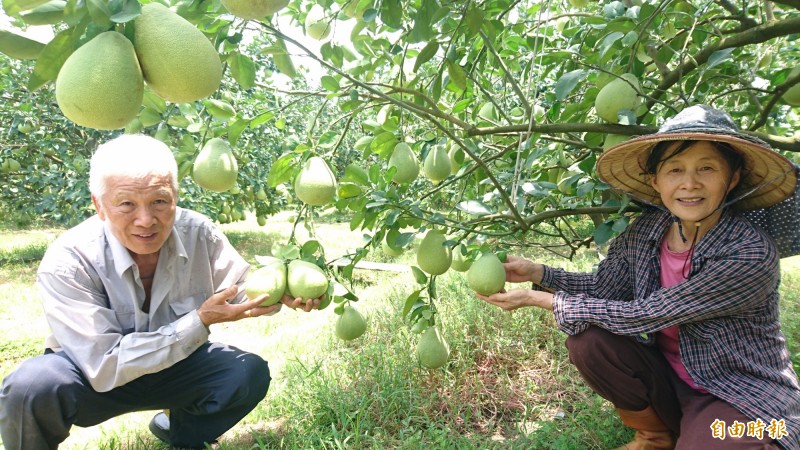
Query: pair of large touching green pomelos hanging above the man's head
56 3 222 130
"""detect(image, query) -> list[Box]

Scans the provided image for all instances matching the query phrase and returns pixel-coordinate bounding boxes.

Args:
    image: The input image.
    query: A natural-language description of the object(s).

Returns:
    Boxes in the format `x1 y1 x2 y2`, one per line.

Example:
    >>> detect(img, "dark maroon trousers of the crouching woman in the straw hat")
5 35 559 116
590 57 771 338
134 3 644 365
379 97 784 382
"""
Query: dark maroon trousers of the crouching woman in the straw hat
567 327 780 450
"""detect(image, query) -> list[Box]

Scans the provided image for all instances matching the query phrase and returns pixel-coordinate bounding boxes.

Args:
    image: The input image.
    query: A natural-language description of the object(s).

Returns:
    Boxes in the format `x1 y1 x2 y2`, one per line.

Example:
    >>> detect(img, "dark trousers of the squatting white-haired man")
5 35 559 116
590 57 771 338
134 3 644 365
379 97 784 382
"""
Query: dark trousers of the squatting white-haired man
0 343 270 450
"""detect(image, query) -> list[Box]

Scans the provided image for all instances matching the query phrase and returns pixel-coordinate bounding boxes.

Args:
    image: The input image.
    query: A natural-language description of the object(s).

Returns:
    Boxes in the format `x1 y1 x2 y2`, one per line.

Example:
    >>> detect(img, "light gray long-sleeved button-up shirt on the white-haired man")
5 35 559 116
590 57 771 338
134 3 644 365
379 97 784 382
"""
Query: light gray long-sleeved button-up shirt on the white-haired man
37 208 249 392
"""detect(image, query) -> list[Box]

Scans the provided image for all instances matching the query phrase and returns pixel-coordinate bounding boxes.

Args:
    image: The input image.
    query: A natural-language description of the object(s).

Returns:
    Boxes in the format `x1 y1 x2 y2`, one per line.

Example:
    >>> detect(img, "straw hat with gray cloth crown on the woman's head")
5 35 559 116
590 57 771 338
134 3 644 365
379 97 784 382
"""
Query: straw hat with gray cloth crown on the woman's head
597 105 797 210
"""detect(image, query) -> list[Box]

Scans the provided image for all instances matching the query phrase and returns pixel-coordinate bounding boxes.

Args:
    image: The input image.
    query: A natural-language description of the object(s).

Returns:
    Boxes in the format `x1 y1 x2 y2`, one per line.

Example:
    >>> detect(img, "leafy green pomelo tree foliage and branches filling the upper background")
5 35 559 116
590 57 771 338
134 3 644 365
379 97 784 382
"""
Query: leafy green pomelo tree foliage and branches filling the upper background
0 0 800 324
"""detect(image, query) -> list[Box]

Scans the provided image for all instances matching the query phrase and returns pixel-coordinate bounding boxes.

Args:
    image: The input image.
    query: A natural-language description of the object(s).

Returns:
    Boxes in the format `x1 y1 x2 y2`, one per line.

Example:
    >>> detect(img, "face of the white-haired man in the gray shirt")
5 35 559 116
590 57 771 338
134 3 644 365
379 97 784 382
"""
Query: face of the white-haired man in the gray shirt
92 175 177 255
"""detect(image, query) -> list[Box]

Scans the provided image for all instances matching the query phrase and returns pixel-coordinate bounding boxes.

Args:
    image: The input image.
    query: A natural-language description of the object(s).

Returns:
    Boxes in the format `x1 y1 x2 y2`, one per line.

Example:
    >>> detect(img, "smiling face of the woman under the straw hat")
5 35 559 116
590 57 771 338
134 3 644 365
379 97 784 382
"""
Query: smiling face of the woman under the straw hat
650 141 739 223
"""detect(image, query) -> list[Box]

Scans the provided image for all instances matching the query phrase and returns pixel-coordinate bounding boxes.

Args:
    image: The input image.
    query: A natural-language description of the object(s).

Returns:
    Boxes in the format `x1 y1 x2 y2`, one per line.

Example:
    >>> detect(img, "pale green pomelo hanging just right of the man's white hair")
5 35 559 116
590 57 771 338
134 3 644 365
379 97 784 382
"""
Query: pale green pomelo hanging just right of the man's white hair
192 138 239 192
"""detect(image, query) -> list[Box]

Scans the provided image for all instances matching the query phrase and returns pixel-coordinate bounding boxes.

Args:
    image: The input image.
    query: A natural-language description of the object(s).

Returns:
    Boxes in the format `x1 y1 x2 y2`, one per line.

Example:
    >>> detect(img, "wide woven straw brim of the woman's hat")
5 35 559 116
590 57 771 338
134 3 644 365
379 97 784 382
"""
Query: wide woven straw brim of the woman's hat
597 132 797 210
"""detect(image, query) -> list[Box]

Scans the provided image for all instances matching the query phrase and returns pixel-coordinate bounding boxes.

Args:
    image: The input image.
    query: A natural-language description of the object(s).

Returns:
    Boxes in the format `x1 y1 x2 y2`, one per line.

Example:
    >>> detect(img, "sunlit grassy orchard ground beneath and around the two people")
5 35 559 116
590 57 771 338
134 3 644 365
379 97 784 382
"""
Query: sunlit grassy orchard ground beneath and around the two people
0 212 800 450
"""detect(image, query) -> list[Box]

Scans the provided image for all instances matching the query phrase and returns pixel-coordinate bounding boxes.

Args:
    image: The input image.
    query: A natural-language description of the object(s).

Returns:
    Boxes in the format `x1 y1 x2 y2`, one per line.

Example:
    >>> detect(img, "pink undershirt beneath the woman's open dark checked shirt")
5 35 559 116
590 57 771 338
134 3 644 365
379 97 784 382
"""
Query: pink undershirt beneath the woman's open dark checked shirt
656 238 708 392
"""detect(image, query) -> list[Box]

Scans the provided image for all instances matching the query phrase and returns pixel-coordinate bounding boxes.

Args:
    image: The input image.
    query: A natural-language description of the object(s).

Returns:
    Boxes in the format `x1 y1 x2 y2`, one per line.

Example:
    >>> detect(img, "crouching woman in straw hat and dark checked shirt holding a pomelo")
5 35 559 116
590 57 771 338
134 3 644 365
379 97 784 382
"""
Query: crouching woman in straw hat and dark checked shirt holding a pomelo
478 105 800 450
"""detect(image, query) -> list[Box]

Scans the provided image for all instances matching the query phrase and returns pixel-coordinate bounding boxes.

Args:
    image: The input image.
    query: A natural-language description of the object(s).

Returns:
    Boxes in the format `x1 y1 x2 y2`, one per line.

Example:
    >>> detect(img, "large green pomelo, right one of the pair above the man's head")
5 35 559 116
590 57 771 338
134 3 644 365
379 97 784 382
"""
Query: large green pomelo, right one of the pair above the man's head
133 2 222 103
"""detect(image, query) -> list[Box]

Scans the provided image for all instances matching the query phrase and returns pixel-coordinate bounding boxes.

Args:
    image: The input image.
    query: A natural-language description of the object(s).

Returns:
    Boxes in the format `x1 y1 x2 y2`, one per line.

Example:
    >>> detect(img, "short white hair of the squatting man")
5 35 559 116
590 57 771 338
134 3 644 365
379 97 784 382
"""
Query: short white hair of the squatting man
89 134 178 199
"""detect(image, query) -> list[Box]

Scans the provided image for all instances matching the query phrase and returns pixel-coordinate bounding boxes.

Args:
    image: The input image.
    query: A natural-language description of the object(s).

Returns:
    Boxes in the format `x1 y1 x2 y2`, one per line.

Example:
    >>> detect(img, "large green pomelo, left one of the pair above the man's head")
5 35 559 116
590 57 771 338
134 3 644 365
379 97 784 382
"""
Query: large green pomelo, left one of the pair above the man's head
56 31 144 130
